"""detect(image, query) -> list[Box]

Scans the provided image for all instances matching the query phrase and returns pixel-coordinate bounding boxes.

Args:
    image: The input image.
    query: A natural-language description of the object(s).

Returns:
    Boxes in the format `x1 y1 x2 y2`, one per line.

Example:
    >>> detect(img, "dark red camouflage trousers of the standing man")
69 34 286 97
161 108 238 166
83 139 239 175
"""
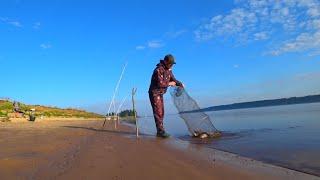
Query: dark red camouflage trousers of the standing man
149 93 164 133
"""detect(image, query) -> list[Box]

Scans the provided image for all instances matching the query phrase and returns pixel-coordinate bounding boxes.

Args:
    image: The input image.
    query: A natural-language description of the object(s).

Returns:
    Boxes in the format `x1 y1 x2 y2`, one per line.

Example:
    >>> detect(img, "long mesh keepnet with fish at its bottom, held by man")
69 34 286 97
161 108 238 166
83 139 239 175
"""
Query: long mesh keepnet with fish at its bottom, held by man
170 87 221 138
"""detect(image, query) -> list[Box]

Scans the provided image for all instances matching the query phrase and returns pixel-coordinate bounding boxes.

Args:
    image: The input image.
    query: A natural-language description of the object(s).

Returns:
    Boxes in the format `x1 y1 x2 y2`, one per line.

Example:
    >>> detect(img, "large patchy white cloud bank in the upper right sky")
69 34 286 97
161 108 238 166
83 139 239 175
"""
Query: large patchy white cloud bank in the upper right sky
194 0 320 55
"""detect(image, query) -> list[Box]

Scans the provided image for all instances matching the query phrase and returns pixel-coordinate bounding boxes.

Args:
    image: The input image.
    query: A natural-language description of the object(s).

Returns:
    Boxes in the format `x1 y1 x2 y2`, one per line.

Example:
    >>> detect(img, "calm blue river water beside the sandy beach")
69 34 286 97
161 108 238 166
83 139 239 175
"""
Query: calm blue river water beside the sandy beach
139 103 320 176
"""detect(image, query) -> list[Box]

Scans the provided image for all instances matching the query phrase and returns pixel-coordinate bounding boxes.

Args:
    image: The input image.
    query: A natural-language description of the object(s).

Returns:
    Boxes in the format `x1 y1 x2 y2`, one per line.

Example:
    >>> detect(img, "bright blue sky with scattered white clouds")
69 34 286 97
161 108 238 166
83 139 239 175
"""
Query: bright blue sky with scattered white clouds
0 0 320 113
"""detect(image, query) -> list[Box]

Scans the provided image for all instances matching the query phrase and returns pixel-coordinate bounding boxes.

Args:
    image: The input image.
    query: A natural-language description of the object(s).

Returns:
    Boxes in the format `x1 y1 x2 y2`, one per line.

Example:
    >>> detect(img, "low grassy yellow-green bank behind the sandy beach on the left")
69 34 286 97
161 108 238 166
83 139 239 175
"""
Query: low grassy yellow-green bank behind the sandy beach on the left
0 99 104 118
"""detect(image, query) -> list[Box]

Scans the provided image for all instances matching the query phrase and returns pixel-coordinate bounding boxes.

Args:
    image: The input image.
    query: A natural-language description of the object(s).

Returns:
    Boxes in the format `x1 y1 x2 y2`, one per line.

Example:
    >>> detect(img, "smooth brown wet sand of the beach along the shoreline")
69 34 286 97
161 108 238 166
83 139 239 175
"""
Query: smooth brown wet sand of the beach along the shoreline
0 120 316 179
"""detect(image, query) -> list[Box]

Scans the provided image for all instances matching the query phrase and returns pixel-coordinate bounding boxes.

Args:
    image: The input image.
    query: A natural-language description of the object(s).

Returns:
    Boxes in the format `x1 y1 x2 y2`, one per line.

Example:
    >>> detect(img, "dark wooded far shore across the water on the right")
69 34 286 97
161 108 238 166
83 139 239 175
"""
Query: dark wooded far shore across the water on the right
201 95 320 111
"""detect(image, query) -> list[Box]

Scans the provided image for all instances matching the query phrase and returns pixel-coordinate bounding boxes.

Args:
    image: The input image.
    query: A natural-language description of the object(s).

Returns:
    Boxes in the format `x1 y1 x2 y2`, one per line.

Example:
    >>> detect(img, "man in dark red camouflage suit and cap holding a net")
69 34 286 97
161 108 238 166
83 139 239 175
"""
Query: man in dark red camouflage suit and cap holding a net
149 54 183 138
